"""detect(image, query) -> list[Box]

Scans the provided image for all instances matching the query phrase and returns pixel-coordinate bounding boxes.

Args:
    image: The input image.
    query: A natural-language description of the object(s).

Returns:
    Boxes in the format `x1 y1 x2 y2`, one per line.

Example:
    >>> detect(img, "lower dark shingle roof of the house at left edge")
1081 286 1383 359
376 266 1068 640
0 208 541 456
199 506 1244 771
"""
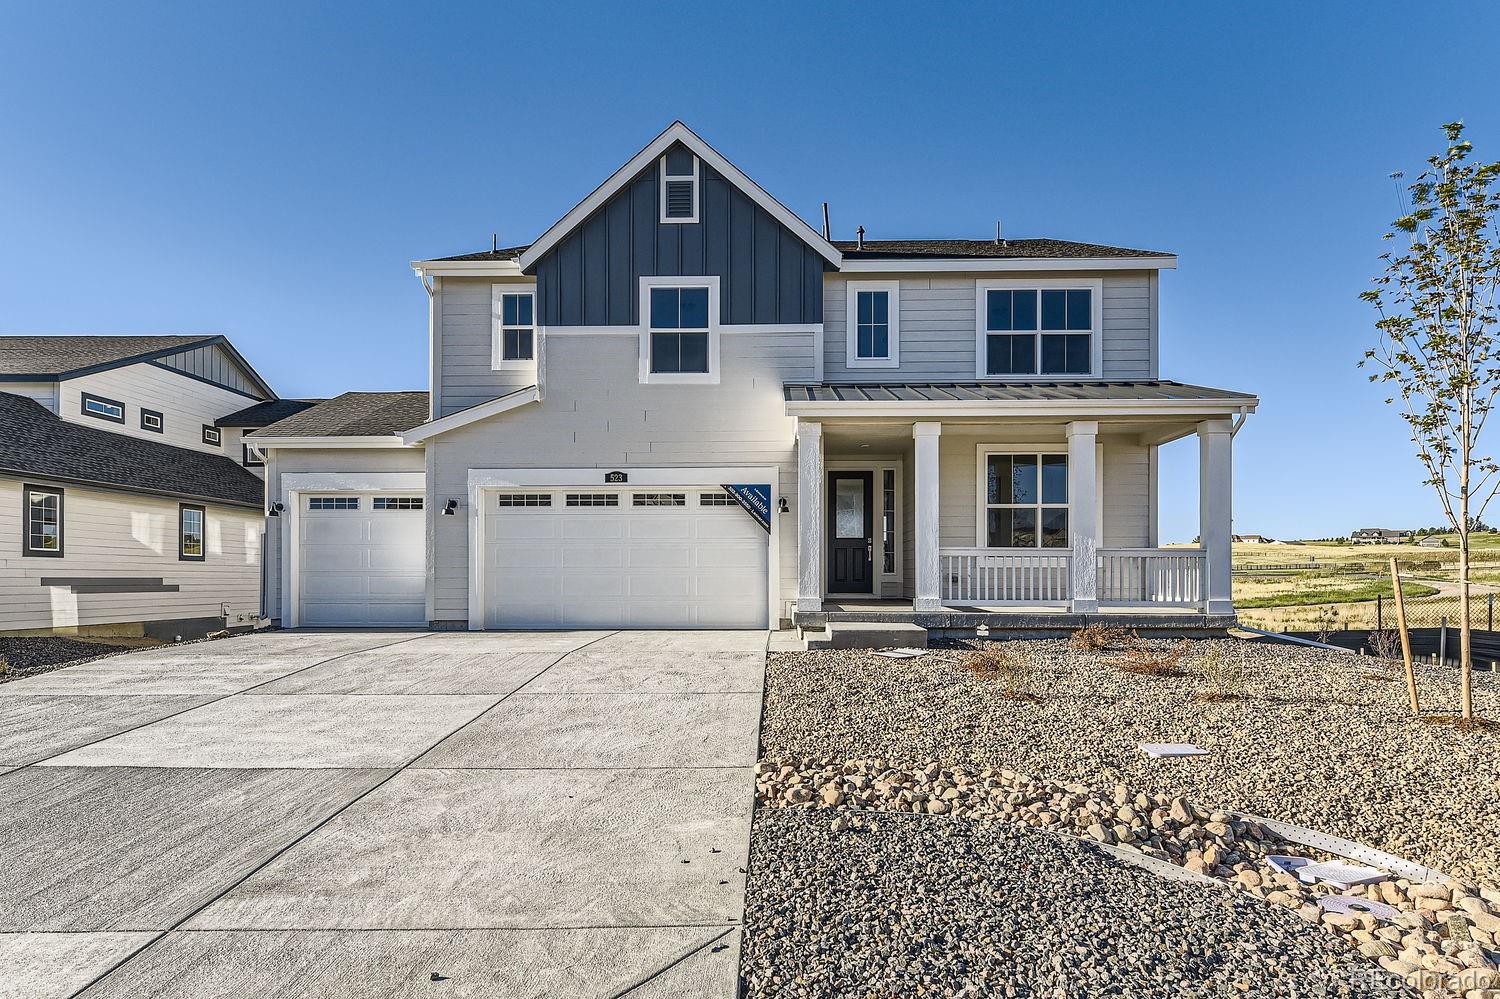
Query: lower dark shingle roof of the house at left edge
0 392 266 507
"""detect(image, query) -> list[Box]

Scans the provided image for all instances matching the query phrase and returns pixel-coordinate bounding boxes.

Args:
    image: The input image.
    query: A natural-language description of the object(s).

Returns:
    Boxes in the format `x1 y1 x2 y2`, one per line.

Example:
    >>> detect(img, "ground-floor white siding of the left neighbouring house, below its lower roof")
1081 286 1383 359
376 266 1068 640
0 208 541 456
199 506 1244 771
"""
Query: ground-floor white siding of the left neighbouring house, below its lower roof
0 479 261 633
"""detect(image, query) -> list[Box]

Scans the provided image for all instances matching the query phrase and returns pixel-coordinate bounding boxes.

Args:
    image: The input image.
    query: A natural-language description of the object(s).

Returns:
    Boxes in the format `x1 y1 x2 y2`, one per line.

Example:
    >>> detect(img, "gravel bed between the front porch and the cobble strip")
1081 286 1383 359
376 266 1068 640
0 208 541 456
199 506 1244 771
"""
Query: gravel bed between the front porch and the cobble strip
762 639 1500 884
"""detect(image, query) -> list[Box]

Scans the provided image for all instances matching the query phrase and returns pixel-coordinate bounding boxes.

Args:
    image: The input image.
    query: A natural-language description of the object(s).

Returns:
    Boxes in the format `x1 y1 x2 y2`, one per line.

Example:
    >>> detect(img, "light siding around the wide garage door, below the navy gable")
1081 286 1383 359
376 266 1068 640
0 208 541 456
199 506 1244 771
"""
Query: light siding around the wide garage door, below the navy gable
429 327 813 621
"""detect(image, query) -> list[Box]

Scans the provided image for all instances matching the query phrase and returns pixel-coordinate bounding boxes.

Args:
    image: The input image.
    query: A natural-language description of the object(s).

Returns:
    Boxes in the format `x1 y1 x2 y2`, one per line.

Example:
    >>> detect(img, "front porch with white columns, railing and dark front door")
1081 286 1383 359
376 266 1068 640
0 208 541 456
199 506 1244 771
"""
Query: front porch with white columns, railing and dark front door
788 383 1254 632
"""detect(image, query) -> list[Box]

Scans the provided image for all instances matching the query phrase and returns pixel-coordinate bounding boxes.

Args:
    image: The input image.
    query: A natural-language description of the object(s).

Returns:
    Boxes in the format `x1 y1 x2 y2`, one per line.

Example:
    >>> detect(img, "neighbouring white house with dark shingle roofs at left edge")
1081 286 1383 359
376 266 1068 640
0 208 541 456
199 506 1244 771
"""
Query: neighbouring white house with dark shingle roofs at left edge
0 336 275 638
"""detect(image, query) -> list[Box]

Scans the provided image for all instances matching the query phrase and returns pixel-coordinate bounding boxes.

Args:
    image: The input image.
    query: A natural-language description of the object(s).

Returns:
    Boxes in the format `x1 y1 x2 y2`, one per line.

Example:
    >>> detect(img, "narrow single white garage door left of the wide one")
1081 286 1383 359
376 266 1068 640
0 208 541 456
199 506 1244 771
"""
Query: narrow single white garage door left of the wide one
299 492 428 627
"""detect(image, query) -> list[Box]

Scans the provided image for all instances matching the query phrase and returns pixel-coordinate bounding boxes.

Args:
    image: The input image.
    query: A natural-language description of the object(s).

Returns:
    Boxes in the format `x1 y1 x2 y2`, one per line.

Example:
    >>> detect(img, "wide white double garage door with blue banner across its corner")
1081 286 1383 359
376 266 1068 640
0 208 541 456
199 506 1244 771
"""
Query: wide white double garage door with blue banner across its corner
485 486 770 629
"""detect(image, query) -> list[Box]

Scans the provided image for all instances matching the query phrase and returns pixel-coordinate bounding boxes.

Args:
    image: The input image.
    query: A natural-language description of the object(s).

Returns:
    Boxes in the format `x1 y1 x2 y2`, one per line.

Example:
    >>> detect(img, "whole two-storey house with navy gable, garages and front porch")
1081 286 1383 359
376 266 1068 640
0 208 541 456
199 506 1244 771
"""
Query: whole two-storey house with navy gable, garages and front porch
248 123 1257 629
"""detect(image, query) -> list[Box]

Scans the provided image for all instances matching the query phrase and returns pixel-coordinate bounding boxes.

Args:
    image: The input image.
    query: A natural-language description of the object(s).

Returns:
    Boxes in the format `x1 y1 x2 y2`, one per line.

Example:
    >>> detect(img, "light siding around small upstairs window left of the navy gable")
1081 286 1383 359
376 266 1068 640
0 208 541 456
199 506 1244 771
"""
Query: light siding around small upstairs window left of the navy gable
437 278 540 417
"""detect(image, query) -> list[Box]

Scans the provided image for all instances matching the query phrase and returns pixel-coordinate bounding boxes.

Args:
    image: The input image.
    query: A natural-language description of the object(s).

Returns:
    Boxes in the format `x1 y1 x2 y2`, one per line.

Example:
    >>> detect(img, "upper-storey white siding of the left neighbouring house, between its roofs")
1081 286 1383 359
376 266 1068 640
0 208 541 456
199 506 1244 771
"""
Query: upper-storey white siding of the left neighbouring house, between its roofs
59 363 255 459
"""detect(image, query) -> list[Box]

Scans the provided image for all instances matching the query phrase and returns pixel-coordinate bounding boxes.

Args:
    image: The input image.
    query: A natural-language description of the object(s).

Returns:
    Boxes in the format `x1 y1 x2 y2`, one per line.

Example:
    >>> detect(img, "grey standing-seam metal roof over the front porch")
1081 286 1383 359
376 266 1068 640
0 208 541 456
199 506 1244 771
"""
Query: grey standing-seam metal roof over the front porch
782 380 1254 402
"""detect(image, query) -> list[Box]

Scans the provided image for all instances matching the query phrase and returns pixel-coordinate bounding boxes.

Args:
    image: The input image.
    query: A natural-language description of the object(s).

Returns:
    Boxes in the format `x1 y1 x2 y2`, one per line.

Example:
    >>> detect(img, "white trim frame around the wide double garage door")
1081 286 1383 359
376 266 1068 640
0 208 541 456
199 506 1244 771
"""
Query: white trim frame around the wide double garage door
468 465 782 632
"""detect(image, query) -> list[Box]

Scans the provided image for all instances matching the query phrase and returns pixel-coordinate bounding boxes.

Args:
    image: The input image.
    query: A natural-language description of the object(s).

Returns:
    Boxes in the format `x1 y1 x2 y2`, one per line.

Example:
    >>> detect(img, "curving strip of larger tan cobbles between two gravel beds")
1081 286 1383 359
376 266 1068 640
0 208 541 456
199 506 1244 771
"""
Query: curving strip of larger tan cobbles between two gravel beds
752 759 1500 999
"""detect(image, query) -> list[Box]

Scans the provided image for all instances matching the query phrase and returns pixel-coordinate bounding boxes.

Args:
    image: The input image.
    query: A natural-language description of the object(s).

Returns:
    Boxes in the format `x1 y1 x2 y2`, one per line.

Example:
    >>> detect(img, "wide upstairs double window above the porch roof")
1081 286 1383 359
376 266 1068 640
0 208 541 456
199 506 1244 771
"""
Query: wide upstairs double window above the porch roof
978 281 1101 378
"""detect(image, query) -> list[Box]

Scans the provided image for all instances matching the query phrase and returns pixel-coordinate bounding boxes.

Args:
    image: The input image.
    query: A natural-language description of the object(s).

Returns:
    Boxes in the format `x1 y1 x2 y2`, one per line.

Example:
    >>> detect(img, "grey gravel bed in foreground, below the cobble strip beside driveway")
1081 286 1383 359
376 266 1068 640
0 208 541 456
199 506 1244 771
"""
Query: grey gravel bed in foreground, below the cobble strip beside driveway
741 809 1418 999
